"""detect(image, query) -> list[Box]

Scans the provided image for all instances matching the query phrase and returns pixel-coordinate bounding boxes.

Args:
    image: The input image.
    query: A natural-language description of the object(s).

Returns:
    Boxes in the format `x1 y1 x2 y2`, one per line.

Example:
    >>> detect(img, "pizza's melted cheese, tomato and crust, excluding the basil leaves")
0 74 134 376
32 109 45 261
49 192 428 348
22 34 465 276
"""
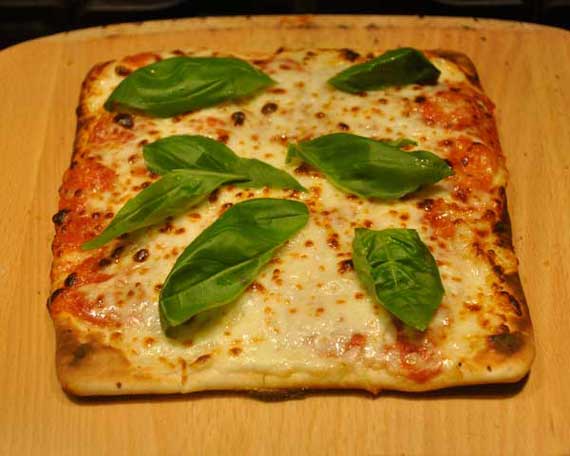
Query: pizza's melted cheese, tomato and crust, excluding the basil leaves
48 50 534 395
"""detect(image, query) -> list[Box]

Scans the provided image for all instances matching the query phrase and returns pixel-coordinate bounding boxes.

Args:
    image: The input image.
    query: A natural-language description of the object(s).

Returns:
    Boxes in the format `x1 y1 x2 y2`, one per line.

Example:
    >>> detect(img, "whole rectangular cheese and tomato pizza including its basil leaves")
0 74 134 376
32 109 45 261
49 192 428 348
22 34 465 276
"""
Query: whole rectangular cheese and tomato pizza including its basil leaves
48 48 534 395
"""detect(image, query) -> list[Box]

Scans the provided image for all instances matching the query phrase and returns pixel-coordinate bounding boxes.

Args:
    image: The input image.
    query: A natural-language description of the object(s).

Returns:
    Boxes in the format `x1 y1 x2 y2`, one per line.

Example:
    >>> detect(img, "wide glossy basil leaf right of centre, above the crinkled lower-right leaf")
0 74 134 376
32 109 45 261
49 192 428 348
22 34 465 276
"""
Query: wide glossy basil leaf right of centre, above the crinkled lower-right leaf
287 133 453 199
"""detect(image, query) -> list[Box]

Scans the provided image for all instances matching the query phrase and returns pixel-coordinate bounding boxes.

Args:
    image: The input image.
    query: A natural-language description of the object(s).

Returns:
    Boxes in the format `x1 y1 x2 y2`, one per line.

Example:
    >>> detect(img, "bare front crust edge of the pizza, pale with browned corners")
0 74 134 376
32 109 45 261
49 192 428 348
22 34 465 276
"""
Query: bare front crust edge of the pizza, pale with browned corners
55 317 534 396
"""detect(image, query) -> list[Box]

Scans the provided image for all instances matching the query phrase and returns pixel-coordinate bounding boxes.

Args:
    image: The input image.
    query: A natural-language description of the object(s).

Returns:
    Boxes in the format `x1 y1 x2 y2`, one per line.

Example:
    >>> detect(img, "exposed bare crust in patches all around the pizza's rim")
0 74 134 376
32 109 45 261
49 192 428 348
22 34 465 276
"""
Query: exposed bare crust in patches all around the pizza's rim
52 50 534 396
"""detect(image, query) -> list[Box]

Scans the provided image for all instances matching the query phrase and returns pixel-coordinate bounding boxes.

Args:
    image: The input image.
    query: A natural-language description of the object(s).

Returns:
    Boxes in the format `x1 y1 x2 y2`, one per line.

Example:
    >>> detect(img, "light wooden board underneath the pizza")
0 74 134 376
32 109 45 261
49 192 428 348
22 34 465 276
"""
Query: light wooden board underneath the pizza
0 16 570 455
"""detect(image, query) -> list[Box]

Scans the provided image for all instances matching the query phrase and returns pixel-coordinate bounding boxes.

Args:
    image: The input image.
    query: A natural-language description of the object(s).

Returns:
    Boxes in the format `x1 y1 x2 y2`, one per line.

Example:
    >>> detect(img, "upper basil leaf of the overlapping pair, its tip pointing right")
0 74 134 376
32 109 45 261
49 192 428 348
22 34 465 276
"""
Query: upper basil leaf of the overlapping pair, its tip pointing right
143 135 305 191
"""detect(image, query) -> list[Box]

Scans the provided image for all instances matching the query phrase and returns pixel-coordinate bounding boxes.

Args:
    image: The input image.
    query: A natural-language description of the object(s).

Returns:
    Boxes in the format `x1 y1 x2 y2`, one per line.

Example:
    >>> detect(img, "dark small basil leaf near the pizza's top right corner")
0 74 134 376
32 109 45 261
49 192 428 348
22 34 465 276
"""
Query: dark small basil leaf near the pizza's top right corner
328 48 441 93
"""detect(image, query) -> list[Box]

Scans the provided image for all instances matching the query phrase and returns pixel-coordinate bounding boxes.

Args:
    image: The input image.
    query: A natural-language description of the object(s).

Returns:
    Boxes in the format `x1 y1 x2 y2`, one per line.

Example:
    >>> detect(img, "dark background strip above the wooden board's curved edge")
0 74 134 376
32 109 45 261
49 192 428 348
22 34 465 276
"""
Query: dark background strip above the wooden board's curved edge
0 0 570 49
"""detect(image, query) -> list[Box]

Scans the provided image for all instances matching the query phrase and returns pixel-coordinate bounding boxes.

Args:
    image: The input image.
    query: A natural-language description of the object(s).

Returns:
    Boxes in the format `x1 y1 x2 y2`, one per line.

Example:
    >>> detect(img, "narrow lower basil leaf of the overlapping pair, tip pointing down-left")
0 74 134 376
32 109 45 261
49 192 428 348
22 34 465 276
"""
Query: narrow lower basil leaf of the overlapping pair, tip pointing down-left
81 170 241 250
